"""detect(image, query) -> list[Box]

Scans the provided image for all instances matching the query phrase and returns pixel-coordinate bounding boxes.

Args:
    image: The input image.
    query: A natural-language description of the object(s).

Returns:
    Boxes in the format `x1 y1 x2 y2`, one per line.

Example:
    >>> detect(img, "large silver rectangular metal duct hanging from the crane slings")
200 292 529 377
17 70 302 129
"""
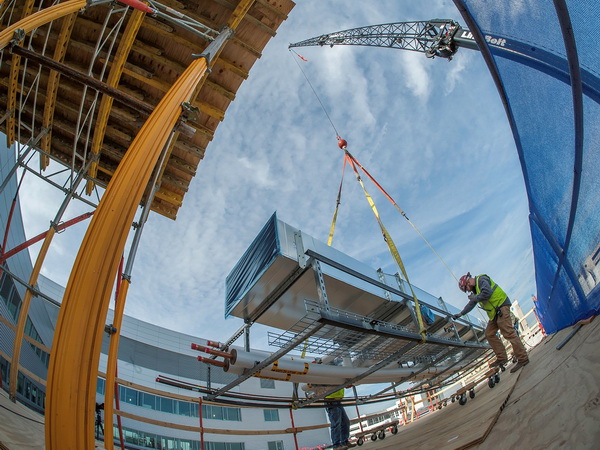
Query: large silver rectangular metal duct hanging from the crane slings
225 214 481 336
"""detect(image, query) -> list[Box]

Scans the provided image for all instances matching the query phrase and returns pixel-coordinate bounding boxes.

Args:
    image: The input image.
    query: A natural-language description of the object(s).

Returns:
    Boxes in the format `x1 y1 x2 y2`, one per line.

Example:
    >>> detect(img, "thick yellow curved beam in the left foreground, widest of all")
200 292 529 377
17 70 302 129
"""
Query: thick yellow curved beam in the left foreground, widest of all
46 58 207 450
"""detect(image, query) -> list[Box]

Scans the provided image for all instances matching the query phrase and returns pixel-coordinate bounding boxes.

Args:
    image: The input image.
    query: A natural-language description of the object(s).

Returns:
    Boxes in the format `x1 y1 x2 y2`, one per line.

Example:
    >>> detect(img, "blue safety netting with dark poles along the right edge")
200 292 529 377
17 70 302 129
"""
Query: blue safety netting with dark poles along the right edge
454 0 600 333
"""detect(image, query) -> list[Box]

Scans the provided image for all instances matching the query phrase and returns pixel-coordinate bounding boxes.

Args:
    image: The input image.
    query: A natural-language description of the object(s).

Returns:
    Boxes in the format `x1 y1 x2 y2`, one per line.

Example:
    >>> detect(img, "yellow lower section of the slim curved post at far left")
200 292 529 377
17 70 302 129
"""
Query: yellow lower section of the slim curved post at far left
9 226 56 401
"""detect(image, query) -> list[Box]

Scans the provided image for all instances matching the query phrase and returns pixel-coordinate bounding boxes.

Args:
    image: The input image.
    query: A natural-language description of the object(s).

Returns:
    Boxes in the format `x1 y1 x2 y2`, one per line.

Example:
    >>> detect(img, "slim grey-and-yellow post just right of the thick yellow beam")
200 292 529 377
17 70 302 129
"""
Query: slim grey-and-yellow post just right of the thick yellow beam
104 131 175 448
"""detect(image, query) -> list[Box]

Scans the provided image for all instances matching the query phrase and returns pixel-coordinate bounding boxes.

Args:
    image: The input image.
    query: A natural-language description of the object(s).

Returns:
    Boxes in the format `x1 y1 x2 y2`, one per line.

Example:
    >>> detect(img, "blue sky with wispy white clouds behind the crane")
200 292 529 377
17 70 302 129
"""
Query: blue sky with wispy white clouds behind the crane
21 0 535 349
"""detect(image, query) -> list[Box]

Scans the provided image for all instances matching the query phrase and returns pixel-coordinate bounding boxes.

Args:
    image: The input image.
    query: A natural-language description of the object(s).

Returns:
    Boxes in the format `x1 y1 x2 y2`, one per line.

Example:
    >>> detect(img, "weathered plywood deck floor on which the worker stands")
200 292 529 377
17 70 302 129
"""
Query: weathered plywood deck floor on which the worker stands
0 319 600 450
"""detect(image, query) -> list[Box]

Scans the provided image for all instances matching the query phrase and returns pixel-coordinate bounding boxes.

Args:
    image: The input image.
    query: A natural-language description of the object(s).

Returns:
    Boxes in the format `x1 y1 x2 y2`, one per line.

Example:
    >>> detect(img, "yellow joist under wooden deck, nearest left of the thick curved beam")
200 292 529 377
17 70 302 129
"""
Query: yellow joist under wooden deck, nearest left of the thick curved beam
85 9 146 195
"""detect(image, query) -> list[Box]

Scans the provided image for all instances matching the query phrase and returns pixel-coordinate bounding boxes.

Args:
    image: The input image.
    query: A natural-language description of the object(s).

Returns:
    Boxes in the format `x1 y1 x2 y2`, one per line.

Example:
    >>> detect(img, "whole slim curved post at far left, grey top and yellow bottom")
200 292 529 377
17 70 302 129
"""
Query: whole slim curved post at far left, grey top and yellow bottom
9 156 94 402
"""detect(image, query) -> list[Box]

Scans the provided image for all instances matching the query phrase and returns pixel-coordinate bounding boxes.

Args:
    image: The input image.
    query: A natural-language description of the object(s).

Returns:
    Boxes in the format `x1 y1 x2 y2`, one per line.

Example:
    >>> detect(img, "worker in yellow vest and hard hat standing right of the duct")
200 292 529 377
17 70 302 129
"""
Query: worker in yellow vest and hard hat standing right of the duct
452 272 529 373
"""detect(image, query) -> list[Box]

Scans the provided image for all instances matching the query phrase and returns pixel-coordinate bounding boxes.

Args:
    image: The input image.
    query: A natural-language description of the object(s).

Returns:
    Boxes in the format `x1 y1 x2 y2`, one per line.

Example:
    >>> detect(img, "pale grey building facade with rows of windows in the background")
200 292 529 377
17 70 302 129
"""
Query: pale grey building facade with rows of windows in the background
0 147 330 450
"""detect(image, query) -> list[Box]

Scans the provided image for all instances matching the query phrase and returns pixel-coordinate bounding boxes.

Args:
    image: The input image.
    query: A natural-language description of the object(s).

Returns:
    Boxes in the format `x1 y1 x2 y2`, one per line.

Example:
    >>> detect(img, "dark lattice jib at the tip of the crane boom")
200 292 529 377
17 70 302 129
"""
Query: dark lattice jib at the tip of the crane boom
290 19 478 60
